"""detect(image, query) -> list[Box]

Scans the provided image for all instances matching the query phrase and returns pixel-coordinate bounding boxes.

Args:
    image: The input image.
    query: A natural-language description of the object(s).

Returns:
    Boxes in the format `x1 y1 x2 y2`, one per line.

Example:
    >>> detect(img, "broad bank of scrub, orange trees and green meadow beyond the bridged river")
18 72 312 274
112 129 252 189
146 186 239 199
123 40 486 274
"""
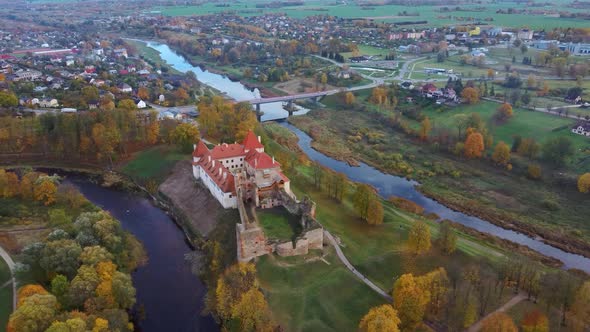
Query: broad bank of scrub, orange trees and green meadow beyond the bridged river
290 86 590 256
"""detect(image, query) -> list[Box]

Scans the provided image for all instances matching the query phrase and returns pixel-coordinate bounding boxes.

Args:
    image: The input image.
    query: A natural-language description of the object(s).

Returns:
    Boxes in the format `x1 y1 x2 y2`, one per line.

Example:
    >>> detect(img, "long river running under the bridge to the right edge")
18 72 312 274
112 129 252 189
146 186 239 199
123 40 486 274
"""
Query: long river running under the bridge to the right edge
147 42 590 273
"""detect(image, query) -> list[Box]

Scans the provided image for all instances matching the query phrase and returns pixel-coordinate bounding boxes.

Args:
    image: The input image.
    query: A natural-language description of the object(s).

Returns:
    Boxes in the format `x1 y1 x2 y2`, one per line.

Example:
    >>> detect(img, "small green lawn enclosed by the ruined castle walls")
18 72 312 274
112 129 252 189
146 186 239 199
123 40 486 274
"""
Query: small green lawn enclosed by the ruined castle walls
256 207 301 240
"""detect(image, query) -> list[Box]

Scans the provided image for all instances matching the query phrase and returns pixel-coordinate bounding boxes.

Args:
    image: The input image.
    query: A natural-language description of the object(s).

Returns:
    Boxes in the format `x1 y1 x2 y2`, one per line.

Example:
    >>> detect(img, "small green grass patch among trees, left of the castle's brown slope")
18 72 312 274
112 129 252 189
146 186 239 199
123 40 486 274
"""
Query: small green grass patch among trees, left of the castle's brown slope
121 145 189 182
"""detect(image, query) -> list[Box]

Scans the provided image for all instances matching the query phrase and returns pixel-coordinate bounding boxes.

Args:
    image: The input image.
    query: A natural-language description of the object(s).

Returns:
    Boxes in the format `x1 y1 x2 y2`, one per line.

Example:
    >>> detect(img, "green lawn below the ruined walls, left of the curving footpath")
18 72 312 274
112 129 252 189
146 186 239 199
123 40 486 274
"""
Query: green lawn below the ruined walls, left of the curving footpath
256 249 385 332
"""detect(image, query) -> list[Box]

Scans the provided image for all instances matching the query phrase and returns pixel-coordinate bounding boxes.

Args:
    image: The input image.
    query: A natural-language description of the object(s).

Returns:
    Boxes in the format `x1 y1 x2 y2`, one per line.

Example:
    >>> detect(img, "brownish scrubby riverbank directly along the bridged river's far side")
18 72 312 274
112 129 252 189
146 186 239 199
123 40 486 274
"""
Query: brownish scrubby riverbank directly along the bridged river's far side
289 110 590 257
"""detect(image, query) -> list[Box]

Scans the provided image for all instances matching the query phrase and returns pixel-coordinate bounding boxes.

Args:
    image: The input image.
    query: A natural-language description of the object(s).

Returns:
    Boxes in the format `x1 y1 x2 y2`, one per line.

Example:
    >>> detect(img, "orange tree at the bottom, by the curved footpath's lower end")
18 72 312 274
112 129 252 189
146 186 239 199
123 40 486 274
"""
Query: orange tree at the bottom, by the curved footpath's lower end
393 274 430 331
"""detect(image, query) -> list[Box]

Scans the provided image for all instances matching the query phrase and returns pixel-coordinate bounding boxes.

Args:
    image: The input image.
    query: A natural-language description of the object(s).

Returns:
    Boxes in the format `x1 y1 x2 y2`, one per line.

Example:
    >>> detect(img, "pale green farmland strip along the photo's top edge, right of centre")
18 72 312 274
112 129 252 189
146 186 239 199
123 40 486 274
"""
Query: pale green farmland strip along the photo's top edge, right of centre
152 0 587 29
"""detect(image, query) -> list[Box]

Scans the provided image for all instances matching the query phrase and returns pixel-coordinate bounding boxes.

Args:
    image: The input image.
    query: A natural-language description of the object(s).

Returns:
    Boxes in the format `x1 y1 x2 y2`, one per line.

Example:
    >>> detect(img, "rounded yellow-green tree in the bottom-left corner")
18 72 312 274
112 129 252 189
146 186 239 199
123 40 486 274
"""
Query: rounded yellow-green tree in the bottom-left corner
7 294 59 332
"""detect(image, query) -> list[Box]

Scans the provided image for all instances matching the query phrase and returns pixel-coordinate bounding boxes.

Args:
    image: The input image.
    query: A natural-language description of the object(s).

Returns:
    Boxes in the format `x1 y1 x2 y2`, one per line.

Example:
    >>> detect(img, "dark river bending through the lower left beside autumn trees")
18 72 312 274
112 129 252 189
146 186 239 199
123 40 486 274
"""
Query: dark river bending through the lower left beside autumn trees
66 174 219 332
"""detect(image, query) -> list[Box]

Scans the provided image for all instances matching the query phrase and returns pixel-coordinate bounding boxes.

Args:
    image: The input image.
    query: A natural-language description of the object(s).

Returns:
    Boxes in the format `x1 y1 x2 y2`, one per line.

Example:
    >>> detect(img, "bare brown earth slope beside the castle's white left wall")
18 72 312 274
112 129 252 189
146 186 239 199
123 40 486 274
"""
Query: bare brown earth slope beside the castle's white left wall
160 160 222 236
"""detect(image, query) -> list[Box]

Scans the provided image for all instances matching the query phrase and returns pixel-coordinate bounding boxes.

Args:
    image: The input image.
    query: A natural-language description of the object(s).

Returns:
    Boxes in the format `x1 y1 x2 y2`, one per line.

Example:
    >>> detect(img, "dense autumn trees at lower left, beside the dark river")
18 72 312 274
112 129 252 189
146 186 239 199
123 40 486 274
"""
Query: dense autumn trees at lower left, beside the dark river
0 169 146 331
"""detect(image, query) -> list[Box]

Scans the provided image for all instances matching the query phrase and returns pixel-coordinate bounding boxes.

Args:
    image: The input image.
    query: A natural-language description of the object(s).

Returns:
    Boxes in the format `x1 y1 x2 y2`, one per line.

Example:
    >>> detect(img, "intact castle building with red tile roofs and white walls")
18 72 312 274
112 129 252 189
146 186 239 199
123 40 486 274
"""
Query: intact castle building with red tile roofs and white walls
193 131 294 209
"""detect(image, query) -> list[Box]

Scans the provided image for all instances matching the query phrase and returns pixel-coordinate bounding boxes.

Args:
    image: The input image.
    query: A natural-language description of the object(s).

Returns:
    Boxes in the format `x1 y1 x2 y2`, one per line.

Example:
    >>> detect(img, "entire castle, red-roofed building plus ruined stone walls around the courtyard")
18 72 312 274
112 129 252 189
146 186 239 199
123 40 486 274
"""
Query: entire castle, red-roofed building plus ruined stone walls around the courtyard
193 131 324 262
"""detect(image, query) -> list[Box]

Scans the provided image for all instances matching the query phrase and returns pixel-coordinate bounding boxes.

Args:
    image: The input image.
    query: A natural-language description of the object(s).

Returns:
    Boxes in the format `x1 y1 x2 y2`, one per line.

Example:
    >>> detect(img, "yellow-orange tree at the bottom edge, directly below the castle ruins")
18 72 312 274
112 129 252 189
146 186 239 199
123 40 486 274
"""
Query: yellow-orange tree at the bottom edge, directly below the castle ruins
231 288 273 332
